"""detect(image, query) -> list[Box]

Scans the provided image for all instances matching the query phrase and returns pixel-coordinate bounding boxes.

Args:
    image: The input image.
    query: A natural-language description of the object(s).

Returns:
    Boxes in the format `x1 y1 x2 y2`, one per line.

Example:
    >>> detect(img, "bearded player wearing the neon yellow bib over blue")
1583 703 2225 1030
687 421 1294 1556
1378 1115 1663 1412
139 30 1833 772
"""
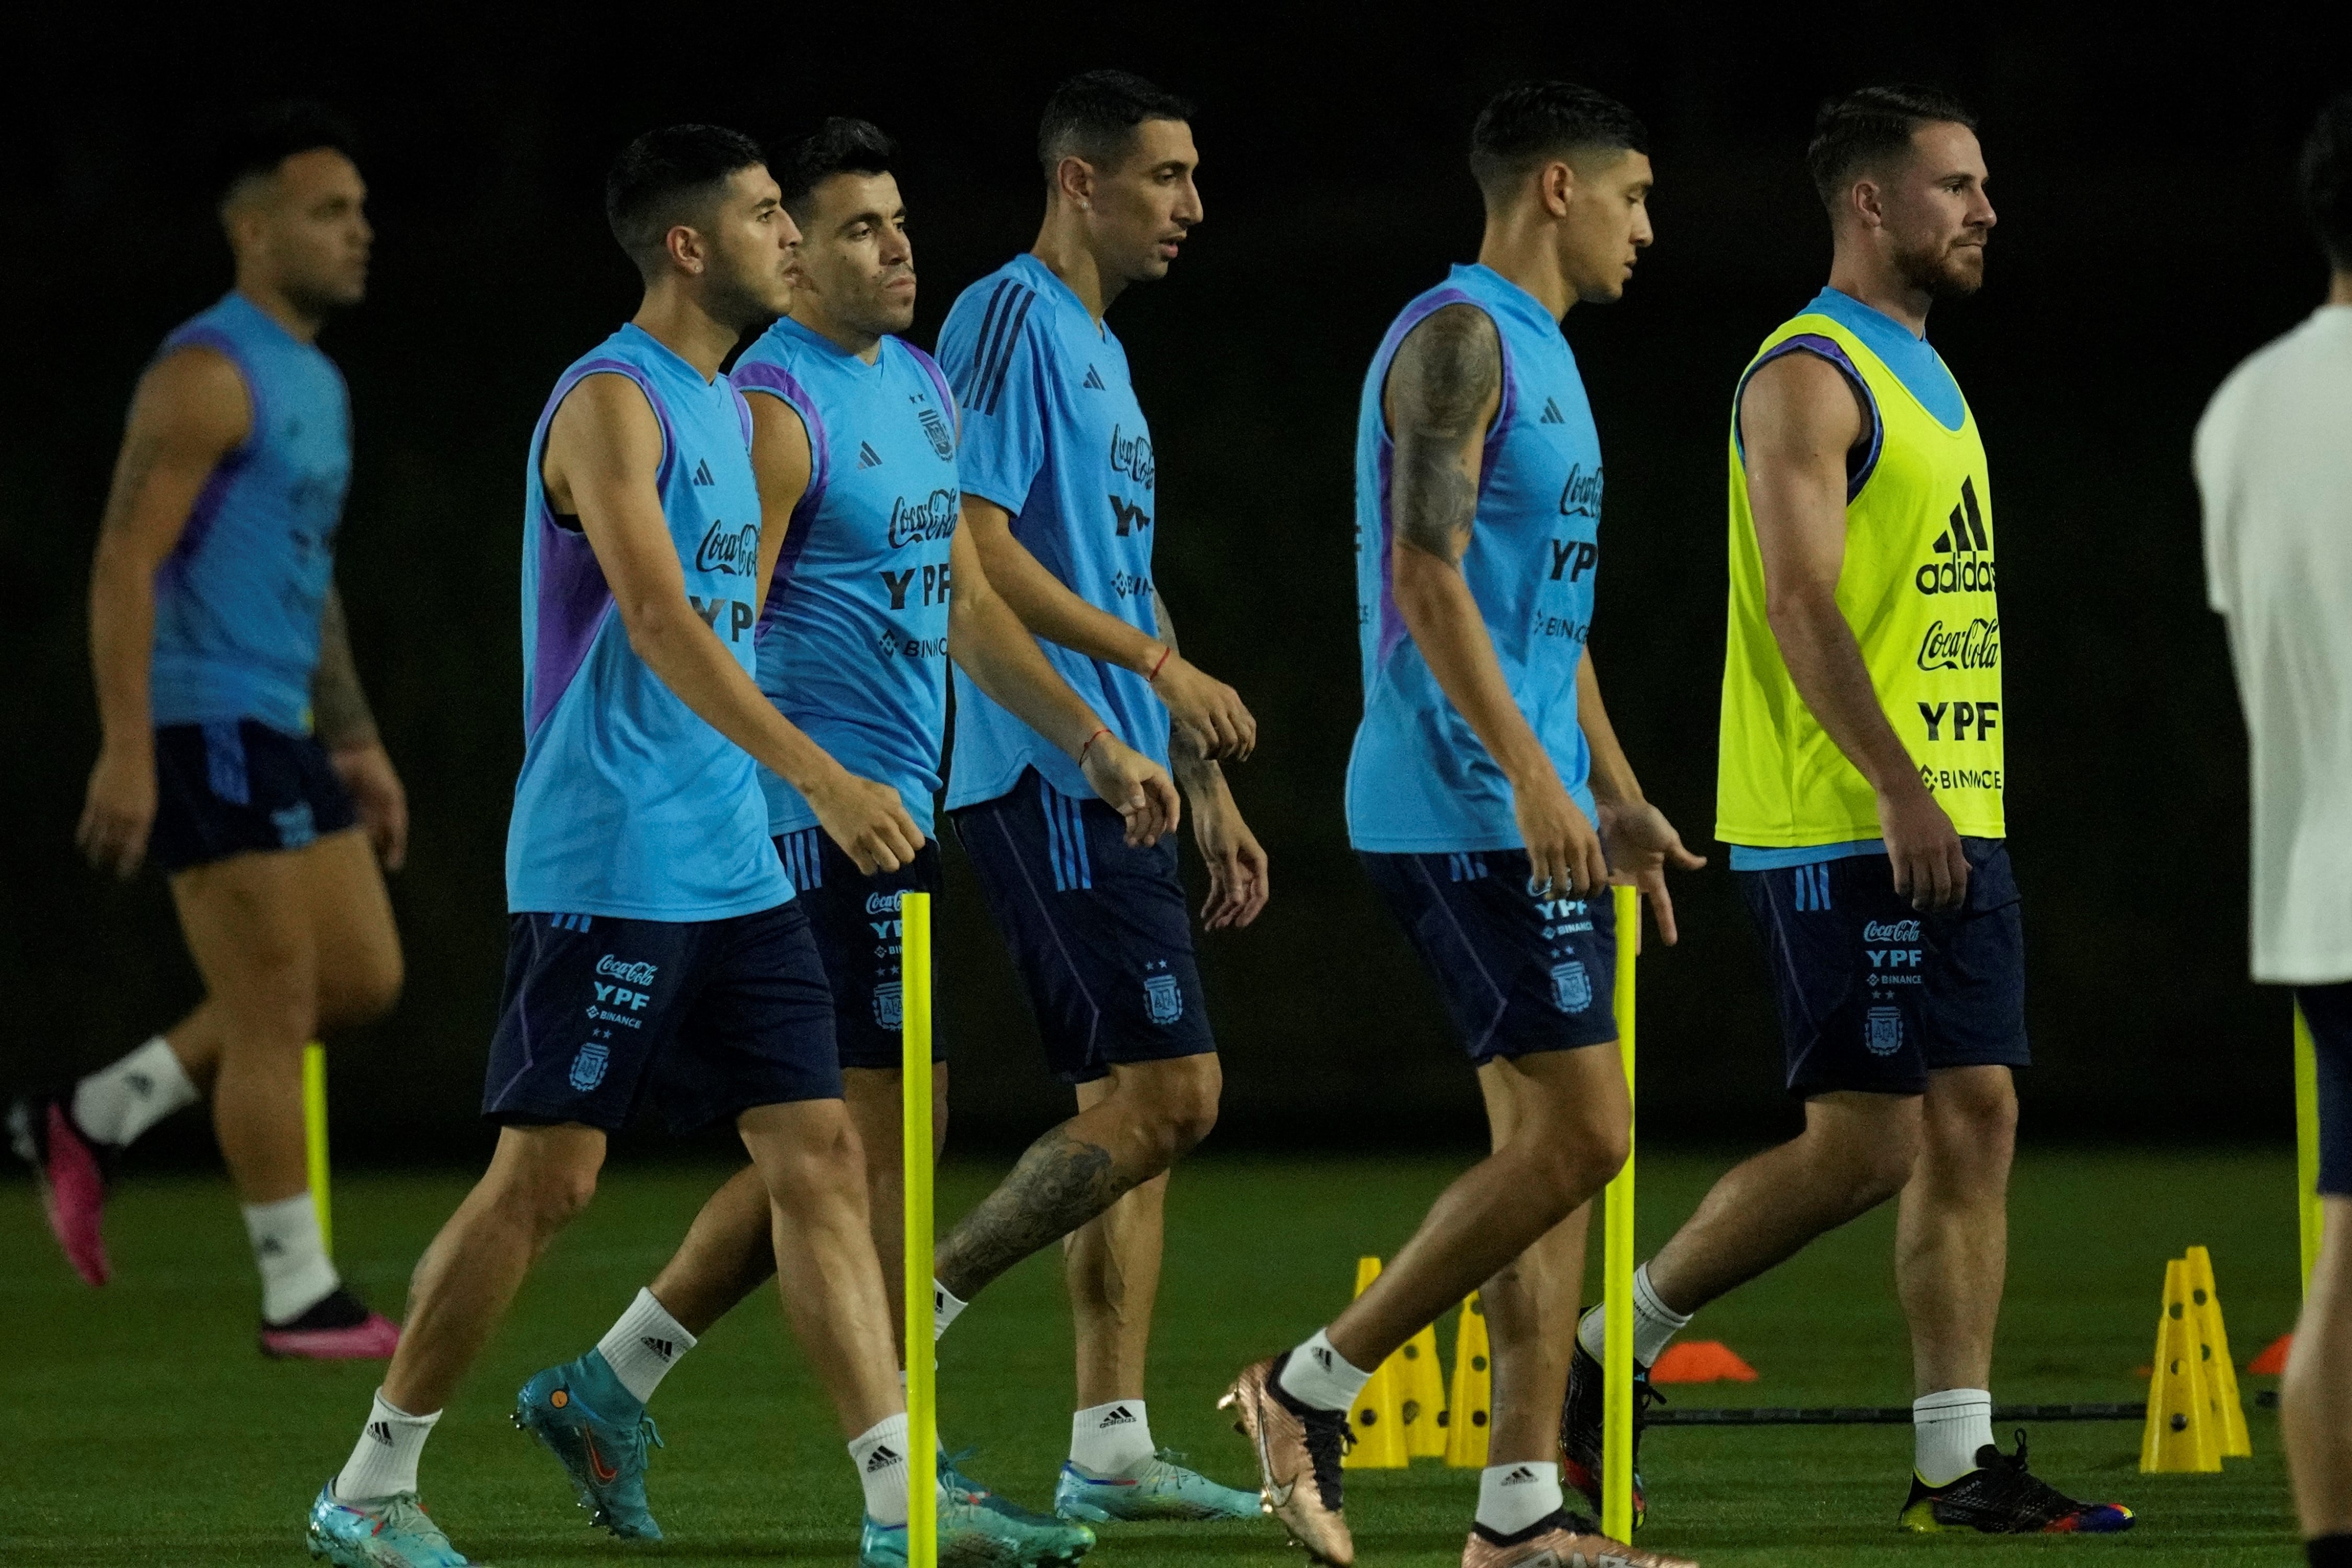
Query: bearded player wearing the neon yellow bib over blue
1562 87 2131 1533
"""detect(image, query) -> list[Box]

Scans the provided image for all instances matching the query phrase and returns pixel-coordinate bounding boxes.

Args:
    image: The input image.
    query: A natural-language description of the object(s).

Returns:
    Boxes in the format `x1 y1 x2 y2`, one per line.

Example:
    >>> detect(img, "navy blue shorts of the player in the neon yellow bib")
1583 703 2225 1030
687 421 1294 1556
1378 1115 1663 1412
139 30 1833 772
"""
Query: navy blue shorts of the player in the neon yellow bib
1738 839 2032 1098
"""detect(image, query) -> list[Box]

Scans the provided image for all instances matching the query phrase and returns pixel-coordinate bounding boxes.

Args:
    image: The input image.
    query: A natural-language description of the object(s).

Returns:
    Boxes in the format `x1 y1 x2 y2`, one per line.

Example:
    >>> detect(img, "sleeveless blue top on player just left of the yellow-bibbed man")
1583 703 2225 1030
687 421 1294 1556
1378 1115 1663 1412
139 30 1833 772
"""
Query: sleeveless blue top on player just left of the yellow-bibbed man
1348 266 1602 854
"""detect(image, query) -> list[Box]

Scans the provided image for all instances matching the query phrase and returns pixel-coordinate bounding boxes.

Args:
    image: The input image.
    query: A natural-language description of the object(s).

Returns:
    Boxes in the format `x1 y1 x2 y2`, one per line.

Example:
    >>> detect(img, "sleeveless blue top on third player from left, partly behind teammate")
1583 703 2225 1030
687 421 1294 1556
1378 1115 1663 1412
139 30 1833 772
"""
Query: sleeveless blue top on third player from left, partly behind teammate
734 317 962 837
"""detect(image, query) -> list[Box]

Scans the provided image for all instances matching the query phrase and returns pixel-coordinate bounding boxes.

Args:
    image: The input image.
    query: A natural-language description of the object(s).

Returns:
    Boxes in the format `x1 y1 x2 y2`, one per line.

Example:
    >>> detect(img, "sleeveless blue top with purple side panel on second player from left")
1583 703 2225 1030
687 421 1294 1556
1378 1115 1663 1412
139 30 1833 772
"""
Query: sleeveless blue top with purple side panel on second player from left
506 322 793 921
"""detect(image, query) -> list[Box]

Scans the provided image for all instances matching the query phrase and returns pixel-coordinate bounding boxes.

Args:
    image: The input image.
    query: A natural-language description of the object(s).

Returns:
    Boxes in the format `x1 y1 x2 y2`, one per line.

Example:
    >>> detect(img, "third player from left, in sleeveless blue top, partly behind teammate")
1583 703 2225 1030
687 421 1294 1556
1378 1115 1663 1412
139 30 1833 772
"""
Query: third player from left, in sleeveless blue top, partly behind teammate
517 120 1179 1561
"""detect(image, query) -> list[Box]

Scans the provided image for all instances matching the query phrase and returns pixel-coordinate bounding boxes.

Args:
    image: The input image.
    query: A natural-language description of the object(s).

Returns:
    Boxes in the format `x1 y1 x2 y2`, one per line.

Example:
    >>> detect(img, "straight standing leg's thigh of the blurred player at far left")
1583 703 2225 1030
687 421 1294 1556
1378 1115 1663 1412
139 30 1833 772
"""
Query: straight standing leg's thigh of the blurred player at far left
172 849 320 1051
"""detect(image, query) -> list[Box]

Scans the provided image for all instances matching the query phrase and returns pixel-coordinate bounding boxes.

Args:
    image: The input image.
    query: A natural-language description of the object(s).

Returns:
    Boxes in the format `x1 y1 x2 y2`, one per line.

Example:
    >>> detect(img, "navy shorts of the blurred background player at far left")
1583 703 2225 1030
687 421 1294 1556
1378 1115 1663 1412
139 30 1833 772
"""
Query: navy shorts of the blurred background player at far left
148 719 360 872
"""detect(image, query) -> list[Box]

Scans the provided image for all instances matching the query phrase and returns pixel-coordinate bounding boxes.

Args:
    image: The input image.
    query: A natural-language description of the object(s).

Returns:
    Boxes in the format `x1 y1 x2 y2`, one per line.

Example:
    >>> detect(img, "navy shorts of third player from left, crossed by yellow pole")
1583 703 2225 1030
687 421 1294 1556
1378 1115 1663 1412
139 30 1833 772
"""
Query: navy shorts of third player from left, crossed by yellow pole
776 827 948 1069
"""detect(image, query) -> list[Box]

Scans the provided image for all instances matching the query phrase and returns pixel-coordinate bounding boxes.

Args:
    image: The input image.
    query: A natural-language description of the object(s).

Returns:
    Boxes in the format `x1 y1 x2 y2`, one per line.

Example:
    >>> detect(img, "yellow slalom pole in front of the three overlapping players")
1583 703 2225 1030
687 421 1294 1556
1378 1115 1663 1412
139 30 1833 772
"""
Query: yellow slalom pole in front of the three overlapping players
898 893 939 1568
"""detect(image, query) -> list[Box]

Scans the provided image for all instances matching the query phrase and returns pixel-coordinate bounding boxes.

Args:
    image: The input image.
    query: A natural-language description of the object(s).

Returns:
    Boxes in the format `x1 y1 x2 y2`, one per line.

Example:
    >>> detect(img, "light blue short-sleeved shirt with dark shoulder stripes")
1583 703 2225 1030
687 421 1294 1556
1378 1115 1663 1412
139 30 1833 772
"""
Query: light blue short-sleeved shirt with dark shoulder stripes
939 256 1169 809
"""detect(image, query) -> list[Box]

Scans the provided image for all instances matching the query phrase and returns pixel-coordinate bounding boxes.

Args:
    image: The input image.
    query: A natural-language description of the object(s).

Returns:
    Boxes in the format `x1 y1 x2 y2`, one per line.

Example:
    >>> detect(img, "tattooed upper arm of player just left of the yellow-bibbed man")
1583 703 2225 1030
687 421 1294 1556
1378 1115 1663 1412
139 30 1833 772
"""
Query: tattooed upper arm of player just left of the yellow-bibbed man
1388 306 1503 562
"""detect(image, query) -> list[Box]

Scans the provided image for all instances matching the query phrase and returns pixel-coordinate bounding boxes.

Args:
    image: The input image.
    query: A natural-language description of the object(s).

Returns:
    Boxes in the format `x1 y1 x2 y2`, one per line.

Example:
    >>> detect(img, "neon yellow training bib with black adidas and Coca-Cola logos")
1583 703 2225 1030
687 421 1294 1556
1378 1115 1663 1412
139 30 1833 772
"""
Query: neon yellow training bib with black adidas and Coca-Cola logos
1715 313 2007 849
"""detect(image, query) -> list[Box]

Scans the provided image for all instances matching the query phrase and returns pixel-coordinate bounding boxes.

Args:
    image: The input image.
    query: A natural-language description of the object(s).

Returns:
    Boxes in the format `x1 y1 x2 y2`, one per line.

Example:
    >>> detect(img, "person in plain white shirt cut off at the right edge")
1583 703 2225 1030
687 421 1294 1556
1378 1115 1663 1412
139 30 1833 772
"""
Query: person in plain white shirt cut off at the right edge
2197 91 2352 1568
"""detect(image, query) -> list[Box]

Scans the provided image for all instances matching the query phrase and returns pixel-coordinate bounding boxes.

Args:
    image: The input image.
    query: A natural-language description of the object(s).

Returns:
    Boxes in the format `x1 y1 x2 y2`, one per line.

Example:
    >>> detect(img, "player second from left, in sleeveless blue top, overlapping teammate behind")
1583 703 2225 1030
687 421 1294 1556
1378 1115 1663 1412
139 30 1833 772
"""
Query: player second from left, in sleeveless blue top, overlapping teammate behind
308 124 946 1568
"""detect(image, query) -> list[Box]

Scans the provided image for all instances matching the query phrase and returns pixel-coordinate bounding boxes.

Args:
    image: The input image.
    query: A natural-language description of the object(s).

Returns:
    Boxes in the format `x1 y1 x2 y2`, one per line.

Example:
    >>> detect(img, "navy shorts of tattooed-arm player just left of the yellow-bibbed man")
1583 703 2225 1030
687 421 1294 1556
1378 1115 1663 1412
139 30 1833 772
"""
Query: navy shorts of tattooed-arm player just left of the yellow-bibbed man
1357 849 1616 1065
